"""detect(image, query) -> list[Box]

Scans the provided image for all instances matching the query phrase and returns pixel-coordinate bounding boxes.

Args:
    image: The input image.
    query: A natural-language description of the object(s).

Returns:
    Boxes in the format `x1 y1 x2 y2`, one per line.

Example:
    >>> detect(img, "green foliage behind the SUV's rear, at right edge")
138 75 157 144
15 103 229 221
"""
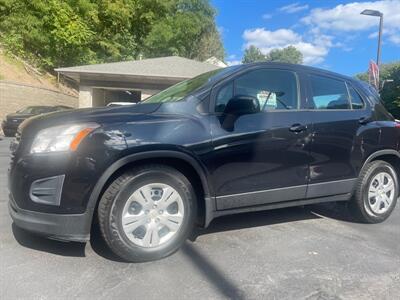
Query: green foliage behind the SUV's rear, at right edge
356 61 400 119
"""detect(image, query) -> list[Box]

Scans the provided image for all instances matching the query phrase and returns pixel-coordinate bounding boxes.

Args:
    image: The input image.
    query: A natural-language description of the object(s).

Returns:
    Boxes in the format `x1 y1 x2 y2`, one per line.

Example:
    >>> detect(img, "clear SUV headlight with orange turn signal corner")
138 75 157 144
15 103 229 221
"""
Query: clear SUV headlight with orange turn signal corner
31 123 99 153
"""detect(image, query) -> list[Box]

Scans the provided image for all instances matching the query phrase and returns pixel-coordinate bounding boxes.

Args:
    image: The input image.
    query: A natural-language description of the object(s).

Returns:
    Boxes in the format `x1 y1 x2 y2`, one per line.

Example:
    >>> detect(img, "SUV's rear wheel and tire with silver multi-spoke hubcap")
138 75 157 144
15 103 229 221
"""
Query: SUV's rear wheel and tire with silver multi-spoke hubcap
349 160 399 223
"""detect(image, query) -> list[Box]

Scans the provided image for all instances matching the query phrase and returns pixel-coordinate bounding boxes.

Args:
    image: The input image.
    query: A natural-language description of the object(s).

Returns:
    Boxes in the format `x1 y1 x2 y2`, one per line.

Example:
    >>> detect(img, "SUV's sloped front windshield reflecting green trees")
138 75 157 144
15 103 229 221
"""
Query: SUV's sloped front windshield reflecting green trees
142 68 231 103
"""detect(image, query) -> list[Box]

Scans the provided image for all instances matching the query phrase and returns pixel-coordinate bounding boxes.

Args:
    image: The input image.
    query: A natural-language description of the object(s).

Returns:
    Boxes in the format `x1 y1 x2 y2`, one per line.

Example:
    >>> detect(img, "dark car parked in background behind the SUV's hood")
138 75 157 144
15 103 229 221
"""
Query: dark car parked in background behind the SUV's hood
1 105 72 137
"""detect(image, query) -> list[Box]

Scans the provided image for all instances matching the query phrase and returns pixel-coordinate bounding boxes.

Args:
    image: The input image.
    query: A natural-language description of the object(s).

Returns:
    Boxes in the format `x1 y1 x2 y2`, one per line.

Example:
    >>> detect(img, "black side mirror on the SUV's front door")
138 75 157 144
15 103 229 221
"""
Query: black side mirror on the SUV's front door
221 95 260 131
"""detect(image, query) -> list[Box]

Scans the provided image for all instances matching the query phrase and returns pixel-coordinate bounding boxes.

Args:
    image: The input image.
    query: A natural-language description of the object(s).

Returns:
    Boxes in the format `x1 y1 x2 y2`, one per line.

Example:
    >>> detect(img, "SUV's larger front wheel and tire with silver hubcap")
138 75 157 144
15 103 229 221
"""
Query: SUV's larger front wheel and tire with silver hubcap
98 165 197 262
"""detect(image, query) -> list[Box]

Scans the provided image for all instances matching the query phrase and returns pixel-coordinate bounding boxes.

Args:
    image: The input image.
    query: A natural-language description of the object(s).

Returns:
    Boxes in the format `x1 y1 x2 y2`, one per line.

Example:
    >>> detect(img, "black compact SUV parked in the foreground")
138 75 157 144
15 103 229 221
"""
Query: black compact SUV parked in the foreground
9 63 400 261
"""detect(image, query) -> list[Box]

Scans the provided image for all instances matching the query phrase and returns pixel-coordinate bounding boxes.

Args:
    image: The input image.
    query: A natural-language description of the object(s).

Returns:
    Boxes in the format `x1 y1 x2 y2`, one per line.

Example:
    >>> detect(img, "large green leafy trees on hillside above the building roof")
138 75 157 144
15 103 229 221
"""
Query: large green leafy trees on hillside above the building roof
0 0 224 70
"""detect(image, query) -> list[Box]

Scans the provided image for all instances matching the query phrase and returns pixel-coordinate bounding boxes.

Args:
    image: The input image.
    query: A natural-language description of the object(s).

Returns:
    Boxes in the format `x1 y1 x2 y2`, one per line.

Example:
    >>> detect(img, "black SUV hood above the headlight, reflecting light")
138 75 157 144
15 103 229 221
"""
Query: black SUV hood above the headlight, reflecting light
19 103 161 136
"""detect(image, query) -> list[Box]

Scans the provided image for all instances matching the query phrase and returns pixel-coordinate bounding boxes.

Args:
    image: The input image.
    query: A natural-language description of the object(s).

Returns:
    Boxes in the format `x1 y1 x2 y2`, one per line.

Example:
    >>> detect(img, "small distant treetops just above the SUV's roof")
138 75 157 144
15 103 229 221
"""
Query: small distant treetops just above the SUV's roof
242 45 303 64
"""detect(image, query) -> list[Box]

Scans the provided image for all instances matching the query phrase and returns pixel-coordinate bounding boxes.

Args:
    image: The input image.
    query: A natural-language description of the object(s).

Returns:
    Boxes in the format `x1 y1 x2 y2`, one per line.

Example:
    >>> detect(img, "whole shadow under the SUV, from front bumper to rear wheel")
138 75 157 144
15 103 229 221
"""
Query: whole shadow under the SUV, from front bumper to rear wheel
12 203 353 262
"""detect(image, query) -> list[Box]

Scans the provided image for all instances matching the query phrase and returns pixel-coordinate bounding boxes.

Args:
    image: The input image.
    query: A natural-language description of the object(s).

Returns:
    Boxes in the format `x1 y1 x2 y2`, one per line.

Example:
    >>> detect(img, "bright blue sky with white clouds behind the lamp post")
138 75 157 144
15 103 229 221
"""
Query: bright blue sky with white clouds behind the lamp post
211 0 400 75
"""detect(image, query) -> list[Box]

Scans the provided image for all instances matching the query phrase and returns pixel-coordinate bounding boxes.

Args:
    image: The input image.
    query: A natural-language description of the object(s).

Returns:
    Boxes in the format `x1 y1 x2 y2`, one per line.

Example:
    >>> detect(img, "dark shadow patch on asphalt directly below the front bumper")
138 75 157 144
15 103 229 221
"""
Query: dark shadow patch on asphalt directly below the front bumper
12 223 85 257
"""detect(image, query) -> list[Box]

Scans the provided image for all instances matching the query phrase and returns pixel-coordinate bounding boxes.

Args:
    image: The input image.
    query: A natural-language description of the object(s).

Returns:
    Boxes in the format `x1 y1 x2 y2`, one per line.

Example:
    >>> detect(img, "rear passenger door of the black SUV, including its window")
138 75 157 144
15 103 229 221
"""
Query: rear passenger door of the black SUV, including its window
307 74 375 198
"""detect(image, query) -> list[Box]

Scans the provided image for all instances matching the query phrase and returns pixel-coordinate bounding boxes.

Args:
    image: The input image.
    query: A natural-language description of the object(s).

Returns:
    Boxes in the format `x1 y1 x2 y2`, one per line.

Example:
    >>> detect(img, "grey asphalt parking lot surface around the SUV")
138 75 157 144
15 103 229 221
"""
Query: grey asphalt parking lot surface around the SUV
0 138 400 300
